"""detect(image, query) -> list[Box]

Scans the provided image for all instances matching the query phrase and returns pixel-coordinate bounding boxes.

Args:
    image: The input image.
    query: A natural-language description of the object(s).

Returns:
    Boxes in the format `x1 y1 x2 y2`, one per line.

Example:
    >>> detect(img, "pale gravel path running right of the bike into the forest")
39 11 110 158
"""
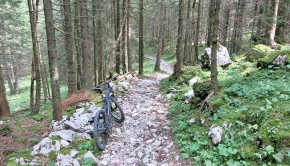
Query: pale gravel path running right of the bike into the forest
98 62 191 166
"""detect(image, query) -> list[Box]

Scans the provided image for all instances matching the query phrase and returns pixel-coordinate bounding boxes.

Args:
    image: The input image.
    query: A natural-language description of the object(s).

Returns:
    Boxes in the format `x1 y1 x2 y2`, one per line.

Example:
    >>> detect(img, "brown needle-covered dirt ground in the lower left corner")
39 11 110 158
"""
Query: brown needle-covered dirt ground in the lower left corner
0 111 49 165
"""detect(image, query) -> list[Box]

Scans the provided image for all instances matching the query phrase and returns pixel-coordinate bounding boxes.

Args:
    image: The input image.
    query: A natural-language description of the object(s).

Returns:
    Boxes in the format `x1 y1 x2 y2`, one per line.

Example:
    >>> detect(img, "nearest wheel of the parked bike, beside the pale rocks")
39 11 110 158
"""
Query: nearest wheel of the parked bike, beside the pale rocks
94 109 109 151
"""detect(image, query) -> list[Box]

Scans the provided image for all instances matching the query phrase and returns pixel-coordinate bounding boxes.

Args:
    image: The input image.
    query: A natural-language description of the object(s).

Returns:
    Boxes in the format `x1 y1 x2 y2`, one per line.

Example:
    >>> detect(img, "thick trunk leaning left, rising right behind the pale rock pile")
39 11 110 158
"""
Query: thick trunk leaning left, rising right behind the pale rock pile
43 0 62 121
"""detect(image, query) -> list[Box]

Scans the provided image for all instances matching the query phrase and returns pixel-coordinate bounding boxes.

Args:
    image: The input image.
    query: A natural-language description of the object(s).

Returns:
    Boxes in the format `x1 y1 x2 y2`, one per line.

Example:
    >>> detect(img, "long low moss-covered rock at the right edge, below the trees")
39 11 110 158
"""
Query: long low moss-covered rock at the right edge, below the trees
257 50 290 68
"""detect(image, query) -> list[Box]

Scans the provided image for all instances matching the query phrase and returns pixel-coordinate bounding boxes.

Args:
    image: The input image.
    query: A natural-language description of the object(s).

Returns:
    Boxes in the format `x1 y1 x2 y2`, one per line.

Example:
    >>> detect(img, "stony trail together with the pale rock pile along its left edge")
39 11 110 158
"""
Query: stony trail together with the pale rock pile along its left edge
4 61 191 166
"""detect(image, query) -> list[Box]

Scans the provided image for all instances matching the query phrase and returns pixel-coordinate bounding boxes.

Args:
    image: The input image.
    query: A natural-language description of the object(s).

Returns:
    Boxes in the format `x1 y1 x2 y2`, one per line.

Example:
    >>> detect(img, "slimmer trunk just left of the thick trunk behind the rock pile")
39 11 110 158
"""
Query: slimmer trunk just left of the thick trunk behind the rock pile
27 0 41 114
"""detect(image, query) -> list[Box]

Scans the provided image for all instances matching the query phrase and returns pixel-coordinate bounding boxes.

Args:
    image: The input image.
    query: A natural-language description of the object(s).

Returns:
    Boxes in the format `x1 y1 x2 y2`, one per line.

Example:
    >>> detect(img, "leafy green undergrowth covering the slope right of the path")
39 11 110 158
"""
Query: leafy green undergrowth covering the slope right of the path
162 57 290 166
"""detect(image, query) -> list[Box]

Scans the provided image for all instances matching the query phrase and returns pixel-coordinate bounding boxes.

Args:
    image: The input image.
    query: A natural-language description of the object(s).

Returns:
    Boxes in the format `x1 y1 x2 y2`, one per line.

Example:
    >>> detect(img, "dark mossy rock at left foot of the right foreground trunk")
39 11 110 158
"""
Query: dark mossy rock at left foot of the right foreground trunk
193 81 211 100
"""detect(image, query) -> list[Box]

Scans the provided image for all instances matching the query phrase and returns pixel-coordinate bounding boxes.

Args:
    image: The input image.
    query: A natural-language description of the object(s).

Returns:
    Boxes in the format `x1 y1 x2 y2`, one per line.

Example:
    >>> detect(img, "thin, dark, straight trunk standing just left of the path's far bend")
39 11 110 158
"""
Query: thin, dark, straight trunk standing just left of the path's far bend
139 0 144 75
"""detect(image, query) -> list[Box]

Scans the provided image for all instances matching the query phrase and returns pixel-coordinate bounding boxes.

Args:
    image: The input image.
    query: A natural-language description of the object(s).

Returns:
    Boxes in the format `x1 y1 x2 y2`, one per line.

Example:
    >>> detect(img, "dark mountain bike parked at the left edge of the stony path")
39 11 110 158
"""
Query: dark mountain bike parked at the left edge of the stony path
92 76 125 151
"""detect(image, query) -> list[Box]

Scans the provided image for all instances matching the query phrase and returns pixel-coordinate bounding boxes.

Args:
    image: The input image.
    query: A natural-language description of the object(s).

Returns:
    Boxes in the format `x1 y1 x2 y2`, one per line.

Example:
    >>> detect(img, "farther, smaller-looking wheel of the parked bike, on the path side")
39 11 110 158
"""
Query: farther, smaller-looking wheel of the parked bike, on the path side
111 97 125 123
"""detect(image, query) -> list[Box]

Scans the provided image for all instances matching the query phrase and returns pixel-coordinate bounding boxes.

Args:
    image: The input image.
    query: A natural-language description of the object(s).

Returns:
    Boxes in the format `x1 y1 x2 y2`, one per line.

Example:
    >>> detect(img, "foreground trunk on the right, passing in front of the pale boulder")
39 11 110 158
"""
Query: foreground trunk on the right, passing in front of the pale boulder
211 0 221 94
